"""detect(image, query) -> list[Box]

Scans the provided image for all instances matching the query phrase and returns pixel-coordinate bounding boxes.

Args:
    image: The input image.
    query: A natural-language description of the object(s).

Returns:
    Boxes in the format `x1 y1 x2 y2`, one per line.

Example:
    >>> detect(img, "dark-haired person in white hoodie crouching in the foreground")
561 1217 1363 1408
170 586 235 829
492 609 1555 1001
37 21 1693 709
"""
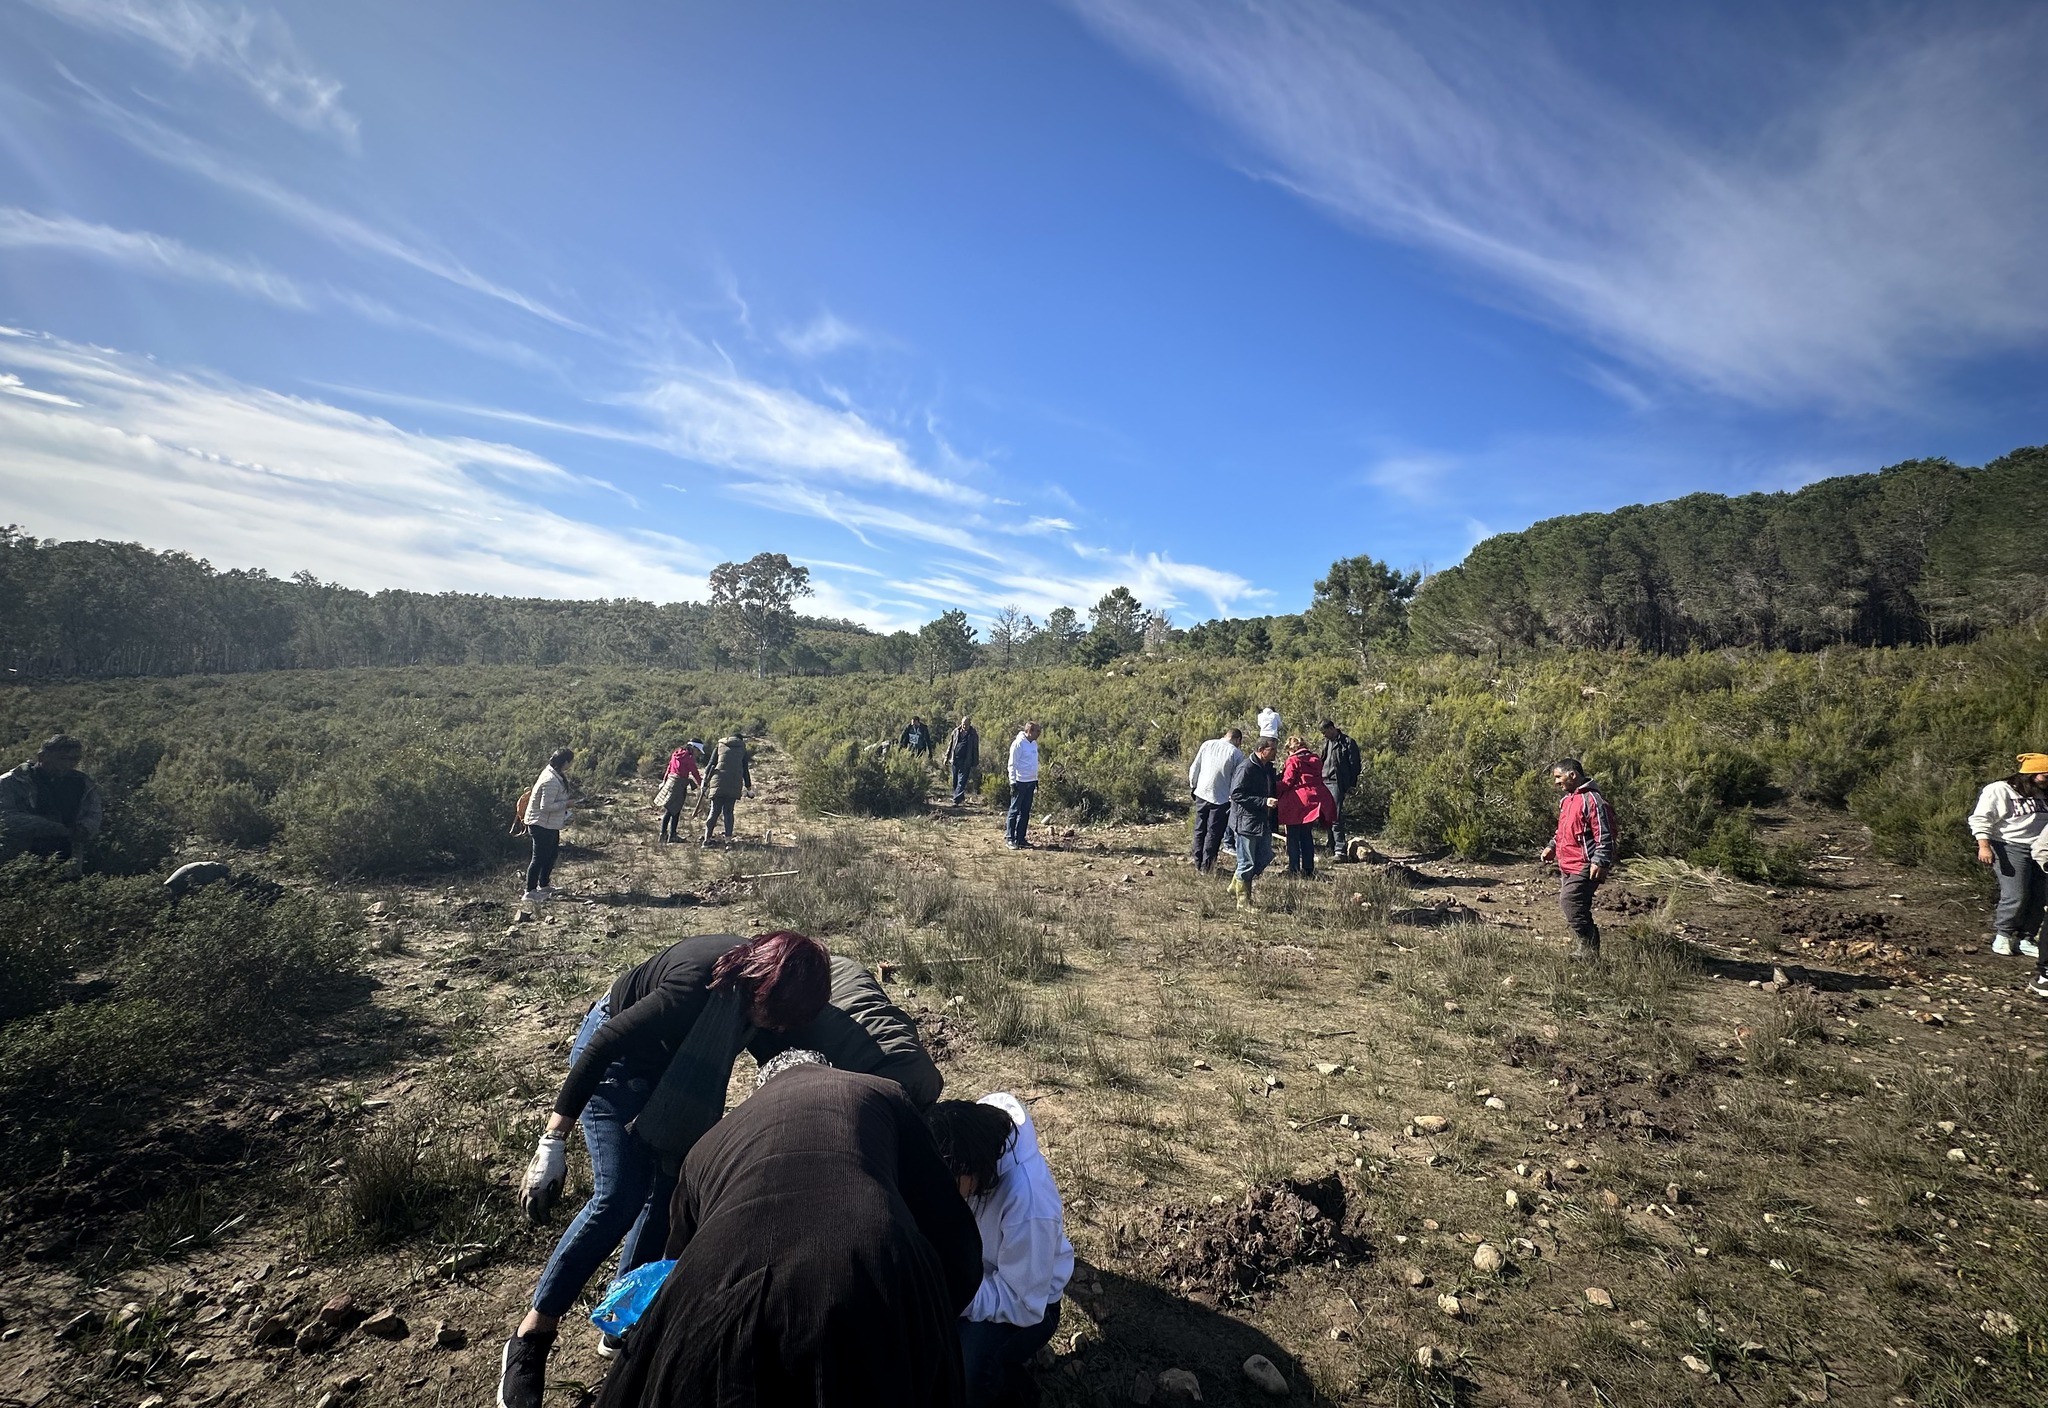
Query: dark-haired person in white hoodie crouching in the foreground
926 1091 1073 1408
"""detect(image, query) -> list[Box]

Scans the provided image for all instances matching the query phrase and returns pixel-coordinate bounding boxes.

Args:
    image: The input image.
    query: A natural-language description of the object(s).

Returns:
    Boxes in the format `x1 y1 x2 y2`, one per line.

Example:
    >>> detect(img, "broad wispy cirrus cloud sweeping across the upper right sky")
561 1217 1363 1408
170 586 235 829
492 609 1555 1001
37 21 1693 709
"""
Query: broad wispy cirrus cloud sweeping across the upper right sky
1069 0 2048 407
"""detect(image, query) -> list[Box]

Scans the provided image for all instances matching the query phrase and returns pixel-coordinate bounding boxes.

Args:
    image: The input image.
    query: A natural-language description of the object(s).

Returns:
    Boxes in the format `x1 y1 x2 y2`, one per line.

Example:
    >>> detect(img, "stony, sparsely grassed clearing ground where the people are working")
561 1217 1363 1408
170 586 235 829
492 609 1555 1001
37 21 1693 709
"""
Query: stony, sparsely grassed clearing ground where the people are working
0 749 2048 1408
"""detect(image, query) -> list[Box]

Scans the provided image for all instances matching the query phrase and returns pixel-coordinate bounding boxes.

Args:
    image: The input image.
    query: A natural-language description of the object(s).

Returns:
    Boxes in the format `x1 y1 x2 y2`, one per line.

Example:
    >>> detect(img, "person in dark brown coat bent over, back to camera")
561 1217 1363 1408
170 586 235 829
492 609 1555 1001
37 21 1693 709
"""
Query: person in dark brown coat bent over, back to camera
598 1052 981 1408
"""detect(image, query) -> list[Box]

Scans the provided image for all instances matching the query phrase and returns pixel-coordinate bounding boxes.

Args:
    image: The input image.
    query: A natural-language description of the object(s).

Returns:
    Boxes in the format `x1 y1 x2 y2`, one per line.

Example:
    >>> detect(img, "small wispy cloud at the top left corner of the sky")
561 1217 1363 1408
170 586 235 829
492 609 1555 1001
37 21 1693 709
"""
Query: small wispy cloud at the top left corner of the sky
29 0 356 143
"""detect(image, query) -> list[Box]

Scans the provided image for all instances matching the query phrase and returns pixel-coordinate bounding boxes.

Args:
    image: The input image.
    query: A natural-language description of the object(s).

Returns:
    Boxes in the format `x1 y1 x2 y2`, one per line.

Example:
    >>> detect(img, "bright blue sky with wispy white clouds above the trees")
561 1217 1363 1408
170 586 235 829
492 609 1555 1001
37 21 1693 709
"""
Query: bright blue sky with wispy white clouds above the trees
0 0 2048 626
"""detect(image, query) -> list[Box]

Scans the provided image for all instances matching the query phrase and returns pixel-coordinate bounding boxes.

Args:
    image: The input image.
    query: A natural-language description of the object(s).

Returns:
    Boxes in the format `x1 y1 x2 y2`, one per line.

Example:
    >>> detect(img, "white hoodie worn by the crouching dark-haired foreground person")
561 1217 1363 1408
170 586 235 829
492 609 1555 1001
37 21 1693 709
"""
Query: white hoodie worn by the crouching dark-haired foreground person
961 1091 1073 1324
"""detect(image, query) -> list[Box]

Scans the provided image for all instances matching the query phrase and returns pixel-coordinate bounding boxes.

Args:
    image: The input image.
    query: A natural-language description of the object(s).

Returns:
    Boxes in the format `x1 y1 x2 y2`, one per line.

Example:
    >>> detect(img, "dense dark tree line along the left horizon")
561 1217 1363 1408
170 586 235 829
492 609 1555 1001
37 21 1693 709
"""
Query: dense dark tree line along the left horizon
0 528 880 677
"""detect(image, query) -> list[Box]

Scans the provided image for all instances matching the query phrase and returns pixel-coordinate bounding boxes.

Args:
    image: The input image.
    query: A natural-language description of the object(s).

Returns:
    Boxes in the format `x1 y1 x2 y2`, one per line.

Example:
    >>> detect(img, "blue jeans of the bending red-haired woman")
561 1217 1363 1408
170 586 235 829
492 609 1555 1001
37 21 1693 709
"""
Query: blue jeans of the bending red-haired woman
532 995 676 1316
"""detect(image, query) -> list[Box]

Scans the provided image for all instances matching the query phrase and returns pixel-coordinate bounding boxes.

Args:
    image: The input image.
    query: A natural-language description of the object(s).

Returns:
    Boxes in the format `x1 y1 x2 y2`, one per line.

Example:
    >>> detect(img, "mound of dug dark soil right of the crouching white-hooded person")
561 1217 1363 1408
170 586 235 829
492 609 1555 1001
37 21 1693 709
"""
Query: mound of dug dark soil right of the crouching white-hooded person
1139 1179 1356 1304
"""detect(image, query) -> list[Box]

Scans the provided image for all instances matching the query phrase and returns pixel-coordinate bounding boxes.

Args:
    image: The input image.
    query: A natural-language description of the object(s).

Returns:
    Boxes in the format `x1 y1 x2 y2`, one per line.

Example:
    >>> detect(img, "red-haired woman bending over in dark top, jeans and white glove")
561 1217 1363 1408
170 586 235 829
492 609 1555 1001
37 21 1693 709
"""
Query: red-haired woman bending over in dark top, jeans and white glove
498 929 831 1408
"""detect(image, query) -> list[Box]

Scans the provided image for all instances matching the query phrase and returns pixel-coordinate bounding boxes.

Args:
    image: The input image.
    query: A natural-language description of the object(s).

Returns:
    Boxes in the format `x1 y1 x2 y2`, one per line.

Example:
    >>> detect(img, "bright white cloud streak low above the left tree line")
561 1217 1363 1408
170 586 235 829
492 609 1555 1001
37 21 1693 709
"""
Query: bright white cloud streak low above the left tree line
0 338 715 600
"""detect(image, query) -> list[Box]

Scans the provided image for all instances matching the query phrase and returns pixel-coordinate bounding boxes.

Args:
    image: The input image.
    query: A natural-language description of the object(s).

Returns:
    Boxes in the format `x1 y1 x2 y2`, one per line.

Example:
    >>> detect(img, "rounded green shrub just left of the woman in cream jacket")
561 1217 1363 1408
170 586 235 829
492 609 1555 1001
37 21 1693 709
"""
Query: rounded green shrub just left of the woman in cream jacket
279 749 512 878
